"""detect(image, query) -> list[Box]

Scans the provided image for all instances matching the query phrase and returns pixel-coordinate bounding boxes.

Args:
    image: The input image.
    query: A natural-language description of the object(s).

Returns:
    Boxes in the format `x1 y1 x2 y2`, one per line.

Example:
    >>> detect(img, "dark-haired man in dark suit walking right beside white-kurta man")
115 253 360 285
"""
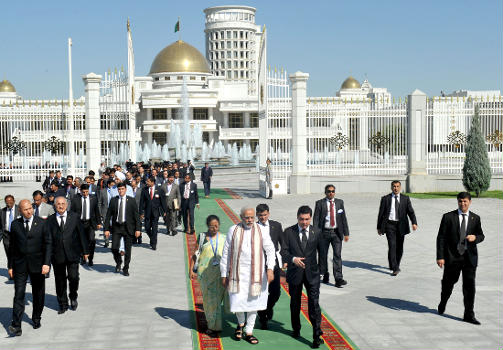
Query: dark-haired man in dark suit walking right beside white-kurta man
281 206 323 348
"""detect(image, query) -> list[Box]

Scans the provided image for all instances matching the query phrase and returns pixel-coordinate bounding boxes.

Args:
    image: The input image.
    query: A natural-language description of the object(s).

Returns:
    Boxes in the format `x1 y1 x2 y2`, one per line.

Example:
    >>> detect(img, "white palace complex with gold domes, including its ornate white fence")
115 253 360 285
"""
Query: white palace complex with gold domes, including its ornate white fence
0 6 503 193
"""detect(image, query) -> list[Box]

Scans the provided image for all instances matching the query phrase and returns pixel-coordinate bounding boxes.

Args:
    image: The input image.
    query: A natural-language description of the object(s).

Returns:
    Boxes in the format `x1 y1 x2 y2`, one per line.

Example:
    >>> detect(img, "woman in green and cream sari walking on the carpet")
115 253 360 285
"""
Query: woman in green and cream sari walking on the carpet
190 215 226 337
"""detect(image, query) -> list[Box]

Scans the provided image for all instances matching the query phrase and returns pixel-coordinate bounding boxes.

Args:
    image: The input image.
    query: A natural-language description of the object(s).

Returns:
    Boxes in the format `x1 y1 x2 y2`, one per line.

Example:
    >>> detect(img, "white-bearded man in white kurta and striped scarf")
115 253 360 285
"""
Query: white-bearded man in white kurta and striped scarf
220 208 276 344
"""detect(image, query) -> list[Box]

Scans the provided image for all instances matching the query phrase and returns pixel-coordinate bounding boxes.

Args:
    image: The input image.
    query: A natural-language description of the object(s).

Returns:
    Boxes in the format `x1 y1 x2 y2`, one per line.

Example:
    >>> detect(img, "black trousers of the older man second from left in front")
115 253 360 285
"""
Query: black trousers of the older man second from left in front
52 261 80 307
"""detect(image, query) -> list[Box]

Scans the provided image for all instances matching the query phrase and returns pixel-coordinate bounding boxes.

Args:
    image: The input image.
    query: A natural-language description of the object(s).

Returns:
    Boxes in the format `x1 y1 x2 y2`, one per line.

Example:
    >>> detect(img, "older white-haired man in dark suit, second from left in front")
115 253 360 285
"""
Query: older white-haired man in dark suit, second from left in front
46 197 92 314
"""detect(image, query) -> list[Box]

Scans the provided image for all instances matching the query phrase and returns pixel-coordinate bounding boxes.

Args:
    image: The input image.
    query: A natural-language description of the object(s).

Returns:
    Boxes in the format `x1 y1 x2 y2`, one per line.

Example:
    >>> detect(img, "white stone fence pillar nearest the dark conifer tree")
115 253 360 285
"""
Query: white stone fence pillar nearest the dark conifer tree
407 89 429 192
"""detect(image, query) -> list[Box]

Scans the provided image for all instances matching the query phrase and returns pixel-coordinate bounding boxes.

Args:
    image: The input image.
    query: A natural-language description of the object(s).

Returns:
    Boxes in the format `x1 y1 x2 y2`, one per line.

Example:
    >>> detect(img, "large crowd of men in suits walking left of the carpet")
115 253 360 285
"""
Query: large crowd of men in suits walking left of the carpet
0 161 213 335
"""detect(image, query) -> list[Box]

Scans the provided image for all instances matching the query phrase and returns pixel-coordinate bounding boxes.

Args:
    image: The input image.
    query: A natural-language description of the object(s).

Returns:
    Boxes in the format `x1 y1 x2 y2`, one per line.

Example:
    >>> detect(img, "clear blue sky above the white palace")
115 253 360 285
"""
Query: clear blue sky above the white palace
0 0 503 99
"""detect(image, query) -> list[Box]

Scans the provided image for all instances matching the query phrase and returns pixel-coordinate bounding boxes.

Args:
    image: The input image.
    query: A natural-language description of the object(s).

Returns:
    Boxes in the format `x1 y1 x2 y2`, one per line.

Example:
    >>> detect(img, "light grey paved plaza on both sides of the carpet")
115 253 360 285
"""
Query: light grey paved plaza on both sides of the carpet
0 178 503 350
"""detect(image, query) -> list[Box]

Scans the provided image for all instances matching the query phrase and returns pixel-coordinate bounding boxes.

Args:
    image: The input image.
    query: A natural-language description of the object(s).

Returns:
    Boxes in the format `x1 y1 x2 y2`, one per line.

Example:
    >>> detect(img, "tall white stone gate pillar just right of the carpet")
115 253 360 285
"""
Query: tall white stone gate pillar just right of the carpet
290 72 311 194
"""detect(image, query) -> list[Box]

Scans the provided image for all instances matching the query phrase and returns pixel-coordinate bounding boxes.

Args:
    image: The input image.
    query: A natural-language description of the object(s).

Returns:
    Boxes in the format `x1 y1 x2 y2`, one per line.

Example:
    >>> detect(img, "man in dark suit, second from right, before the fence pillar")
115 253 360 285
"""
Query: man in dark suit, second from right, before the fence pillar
377 180 417 276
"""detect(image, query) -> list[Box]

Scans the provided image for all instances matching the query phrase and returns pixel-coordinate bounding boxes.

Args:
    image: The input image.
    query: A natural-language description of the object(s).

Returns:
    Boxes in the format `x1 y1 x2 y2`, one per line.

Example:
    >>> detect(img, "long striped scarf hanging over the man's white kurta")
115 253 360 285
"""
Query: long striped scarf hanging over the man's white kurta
229 222 264 297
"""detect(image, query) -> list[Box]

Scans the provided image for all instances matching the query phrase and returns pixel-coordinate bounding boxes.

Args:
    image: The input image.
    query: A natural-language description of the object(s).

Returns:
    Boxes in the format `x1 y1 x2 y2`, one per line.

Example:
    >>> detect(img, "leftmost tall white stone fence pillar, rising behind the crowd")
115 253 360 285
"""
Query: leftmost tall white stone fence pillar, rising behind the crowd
82 73 102 173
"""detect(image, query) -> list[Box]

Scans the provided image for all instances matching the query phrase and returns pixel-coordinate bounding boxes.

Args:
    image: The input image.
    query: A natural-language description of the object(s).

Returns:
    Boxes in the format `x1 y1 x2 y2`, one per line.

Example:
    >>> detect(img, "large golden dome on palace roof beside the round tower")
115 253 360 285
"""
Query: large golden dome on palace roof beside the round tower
149 40 210 74
